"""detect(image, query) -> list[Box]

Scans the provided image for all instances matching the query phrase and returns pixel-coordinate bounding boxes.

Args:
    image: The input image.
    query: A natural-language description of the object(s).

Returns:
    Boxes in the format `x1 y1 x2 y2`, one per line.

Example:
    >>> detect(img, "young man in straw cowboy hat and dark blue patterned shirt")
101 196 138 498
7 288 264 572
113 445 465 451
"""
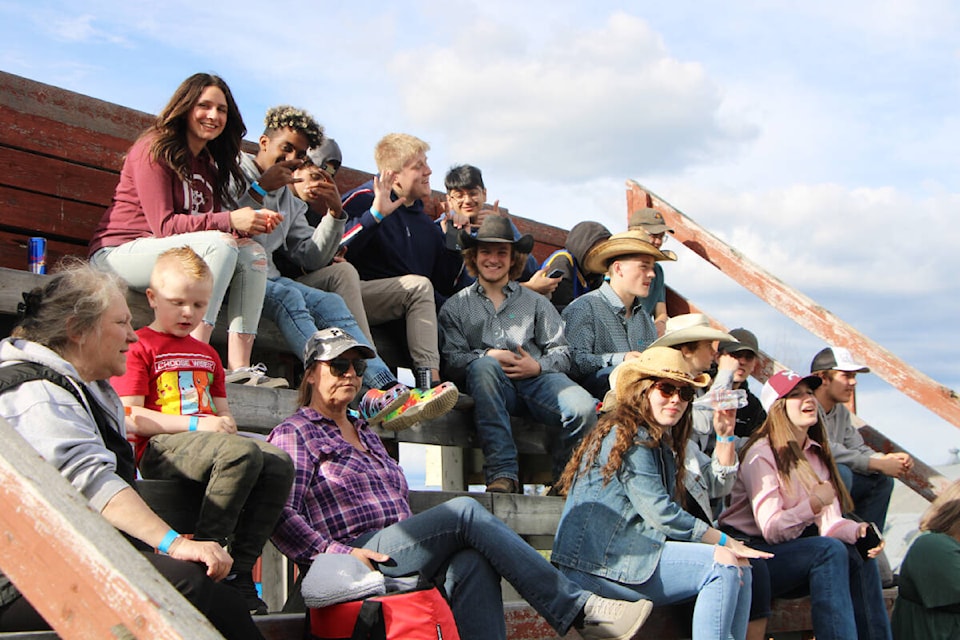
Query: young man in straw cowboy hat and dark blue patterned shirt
563 231 676 399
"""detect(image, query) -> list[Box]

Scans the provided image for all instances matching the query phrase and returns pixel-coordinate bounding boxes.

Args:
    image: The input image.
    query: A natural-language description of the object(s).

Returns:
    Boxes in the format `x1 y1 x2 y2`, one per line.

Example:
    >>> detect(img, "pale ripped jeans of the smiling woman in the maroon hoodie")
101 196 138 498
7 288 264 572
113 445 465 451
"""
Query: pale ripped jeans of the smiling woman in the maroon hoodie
90 231 267 334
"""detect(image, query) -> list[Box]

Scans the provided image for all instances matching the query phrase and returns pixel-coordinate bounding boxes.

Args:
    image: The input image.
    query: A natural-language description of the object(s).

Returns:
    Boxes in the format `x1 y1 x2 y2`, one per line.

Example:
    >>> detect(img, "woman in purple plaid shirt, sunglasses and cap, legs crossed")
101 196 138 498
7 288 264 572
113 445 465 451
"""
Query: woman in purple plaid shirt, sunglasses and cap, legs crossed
268 328 650 640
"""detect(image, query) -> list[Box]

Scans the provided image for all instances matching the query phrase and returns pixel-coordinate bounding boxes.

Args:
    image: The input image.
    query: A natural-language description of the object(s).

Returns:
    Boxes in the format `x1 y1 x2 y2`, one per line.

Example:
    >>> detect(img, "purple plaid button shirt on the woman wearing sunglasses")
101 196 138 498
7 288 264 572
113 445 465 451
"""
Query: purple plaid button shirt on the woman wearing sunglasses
267 407 410 564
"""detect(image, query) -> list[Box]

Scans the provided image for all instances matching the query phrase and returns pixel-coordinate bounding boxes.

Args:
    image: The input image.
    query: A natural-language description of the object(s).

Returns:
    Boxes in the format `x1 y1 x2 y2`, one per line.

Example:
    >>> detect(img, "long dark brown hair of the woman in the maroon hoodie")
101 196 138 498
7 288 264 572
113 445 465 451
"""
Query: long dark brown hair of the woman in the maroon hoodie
141 73 247 206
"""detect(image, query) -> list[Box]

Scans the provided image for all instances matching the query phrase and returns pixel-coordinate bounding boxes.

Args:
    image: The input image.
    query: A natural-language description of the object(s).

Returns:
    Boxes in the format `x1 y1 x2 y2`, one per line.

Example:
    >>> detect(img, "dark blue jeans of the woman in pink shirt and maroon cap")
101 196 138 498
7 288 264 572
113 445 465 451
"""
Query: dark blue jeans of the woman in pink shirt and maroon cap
752 536 892 640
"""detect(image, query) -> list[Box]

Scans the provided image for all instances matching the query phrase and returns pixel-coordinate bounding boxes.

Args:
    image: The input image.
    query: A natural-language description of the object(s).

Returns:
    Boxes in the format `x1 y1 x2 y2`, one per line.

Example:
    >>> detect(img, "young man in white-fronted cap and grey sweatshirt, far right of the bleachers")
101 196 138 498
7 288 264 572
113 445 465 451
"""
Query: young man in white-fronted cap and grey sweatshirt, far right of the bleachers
810 347 913 531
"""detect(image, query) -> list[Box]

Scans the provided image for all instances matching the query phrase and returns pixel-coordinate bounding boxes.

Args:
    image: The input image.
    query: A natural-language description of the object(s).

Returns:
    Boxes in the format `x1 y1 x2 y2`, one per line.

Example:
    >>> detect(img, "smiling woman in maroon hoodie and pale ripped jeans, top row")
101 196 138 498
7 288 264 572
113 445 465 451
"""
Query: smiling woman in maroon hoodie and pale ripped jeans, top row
90 73 285 386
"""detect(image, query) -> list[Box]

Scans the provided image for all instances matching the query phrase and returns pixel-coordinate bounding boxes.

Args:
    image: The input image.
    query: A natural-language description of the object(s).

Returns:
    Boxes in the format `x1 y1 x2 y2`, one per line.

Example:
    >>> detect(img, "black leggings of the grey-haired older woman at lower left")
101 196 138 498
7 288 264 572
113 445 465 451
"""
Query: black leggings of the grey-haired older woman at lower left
0 552 263 640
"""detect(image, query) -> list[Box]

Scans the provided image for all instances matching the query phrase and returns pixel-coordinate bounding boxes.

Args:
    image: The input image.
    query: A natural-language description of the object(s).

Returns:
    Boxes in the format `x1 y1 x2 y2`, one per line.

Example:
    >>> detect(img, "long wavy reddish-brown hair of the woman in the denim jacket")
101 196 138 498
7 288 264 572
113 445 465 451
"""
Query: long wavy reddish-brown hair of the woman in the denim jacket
557 378 693 508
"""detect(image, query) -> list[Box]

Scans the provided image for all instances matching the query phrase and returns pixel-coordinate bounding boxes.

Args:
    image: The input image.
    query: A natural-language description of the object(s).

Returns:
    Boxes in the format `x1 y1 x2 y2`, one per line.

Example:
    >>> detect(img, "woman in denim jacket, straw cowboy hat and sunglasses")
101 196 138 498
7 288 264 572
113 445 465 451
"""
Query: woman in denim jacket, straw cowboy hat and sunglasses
552 347 769 640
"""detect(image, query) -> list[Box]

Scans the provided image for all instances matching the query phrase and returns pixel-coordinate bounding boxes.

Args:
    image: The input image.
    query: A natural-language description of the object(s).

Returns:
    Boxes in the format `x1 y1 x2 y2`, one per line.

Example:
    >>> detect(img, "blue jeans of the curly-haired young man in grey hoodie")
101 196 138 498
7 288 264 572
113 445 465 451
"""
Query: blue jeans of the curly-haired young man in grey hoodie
263 276 397 389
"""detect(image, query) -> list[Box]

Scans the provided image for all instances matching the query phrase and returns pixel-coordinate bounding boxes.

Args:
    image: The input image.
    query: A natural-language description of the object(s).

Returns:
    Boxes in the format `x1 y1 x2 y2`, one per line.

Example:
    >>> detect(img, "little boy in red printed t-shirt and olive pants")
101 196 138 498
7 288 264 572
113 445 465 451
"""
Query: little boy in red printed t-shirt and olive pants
111 247 293 614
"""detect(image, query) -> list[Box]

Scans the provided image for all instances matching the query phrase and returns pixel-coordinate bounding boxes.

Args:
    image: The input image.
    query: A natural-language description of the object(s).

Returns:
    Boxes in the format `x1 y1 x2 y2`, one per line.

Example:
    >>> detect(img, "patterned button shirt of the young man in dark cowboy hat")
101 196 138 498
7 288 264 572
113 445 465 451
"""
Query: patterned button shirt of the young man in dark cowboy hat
437 280 571 378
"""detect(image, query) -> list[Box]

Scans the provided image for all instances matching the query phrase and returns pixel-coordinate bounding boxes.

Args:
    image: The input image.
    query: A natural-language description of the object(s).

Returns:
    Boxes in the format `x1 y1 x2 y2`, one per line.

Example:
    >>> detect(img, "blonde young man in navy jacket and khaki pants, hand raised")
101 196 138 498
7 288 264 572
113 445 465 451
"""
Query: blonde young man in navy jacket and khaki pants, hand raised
343 133 463 388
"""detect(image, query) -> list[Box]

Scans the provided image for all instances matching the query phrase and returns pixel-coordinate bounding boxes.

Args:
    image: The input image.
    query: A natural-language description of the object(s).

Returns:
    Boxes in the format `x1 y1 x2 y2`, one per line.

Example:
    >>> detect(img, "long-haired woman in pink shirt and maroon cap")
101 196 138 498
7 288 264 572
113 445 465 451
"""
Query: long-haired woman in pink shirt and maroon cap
720 371 891 640
